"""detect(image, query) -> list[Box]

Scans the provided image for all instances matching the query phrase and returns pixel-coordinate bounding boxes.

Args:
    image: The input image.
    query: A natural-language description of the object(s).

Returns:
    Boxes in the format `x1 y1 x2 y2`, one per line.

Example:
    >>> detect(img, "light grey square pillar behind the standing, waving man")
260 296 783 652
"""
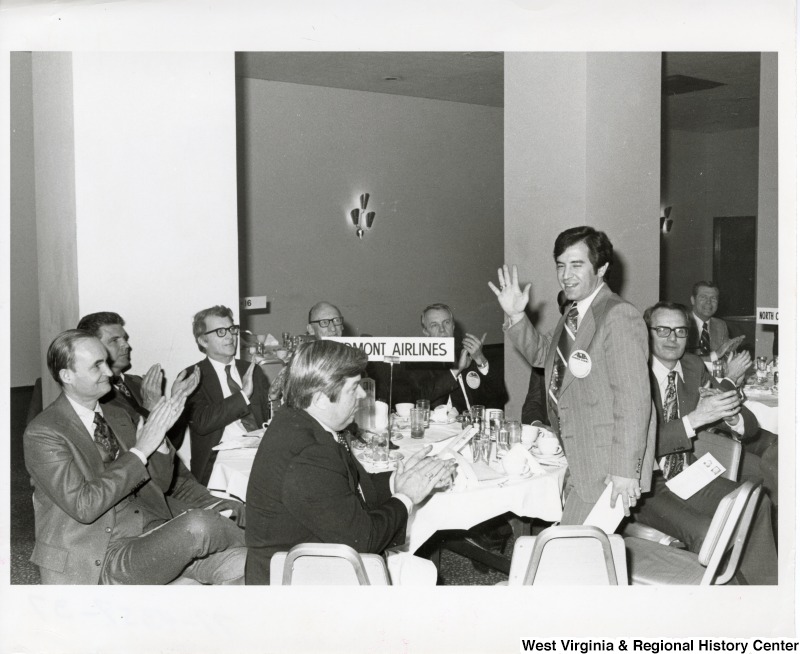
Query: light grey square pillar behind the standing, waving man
505 53 661 415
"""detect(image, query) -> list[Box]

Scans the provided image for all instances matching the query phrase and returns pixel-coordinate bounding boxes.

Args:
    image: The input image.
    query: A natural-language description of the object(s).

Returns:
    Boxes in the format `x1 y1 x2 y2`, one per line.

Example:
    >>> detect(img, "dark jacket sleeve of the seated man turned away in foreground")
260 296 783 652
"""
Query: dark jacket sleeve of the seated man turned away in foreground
282 444 408 553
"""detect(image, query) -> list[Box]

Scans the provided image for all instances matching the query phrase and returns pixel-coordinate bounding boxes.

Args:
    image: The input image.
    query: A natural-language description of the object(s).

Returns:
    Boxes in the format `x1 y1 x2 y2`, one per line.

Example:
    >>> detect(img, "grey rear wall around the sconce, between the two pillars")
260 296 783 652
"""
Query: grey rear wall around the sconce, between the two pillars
238 79 503 343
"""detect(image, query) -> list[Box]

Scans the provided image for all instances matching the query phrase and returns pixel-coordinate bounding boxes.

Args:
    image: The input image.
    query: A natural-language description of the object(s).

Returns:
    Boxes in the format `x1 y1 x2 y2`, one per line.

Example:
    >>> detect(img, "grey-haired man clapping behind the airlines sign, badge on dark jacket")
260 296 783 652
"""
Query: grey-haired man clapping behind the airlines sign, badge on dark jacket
397 303 508 413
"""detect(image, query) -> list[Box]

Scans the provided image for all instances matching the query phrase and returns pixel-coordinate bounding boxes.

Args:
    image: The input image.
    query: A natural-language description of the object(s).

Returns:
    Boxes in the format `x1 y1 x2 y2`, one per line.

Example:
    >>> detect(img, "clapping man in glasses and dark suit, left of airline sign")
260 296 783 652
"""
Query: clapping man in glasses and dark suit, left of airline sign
186 305 269 485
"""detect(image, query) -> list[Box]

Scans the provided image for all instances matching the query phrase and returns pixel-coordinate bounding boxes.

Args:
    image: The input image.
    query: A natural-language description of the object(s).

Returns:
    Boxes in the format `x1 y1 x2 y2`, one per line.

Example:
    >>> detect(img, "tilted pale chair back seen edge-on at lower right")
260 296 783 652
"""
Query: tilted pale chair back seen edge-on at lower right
697 481 761 586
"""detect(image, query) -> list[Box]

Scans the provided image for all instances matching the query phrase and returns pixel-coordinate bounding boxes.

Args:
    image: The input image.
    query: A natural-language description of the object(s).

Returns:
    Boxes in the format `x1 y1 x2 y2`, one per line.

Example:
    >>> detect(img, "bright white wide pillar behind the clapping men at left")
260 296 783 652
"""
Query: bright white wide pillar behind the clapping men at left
28 53 238 403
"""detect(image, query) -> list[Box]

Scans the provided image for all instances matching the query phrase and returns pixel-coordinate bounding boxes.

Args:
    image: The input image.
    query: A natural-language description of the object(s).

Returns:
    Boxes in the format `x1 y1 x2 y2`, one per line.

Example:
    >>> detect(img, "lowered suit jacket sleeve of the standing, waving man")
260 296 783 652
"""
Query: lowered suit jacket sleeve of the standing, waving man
603 302 652 479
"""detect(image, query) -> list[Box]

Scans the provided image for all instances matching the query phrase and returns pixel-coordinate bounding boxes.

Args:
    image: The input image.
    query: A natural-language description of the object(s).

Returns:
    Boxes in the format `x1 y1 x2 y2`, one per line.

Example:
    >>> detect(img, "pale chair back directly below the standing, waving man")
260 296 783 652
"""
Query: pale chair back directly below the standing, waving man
508 525 628 586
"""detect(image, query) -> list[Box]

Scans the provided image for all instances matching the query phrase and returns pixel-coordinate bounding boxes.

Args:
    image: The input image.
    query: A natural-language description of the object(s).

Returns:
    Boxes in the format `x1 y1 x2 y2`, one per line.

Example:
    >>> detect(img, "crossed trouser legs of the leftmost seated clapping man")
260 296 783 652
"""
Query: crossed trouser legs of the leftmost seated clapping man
100 509 247 585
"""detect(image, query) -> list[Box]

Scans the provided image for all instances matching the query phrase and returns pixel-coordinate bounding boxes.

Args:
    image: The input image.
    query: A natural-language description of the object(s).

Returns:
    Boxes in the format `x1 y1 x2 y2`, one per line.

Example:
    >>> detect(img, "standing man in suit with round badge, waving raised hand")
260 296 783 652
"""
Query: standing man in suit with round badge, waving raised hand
489 227 655 524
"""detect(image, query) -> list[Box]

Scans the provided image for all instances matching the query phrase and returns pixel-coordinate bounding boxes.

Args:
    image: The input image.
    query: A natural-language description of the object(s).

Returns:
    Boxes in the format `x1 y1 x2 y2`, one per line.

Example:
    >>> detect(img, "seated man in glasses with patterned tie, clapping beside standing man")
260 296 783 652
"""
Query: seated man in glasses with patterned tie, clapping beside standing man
636 302 778 584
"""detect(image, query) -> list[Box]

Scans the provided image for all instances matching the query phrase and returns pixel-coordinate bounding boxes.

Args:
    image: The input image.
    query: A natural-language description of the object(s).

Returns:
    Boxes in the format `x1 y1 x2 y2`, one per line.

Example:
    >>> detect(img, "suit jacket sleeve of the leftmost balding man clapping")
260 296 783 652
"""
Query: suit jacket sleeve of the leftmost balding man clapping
24 423 150 524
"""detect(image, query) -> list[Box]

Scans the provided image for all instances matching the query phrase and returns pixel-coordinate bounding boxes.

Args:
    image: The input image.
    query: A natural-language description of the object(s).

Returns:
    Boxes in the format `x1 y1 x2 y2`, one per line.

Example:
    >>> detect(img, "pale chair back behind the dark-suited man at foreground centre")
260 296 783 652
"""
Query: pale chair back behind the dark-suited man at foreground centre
270 543 389 586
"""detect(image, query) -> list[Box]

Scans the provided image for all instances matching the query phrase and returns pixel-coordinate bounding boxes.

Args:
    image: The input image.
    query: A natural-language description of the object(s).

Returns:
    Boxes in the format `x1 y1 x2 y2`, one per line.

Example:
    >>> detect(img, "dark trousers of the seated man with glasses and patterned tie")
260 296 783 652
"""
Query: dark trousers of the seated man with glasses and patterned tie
635 473 778 584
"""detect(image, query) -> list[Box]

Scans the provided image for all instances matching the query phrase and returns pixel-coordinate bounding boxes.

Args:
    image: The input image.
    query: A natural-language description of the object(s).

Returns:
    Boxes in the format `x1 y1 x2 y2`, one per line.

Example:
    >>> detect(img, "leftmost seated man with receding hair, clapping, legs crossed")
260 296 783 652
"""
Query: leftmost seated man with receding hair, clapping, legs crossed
23 329 245 584
